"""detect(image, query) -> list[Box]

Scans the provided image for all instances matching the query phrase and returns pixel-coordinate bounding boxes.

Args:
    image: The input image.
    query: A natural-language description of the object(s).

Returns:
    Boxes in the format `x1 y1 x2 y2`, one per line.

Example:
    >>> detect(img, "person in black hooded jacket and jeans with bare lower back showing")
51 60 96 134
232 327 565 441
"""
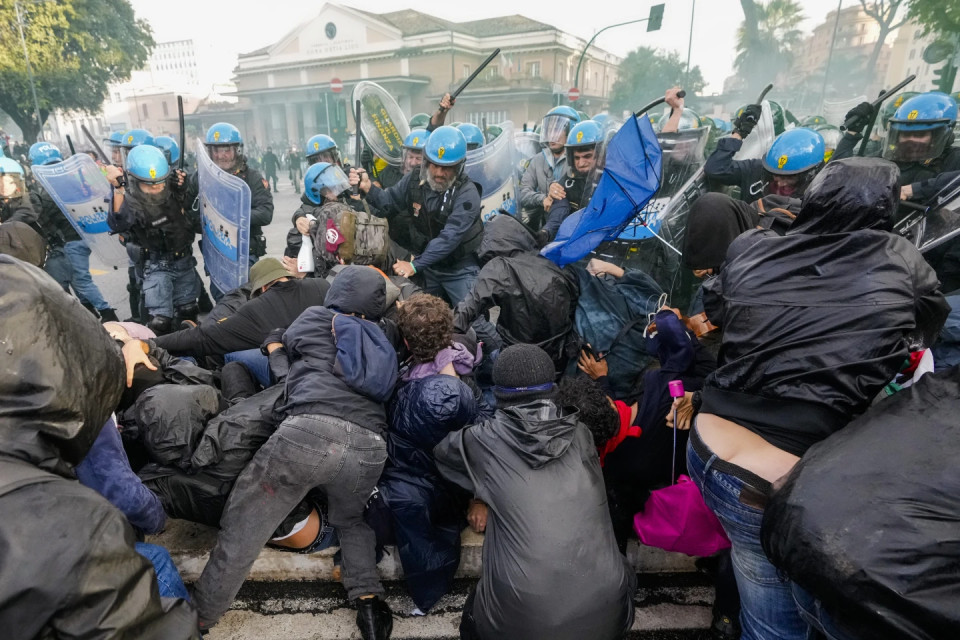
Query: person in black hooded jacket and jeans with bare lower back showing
687 158 947 638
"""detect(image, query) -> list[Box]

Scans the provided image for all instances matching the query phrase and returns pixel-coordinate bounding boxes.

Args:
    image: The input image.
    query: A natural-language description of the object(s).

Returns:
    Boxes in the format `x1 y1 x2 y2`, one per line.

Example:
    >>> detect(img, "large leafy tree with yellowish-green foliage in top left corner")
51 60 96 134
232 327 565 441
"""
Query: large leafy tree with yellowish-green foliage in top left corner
0 0 154 142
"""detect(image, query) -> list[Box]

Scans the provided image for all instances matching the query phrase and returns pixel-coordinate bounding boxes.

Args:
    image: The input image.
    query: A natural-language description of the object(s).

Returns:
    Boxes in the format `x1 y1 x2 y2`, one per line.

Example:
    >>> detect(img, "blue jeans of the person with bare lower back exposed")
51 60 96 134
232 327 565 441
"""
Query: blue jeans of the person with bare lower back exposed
687 426 809 640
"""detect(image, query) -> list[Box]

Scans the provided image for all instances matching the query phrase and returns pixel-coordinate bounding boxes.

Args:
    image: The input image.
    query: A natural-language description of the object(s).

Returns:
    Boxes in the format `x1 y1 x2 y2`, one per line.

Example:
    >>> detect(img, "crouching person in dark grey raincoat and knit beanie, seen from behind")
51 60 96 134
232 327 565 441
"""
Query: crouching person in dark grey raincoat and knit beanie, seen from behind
434 344 636 640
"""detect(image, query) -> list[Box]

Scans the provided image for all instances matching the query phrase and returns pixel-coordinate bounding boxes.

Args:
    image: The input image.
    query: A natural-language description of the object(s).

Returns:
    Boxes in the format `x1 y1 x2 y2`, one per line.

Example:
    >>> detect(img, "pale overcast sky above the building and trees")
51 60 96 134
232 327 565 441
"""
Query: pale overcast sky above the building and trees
131 0 880 93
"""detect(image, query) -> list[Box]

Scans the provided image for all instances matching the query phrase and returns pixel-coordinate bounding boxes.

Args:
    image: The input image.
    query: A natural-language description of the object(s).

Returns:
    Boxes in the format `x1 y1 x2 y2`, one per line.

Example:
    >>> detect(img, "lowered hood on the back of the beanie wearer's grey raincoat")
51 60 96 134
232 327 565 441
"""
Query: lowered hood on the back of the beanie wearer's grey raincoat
497 400 577 469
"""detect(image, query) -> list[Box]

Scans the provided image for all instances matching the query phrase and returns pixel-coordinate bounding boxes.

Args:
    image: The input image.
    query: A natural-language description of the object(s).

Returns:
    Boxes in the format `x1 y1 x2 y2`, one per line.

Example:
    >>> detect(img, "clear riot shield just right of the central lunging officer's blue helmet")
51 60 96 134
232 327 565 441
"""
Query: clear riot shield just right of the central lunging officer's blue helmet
464 122 517 222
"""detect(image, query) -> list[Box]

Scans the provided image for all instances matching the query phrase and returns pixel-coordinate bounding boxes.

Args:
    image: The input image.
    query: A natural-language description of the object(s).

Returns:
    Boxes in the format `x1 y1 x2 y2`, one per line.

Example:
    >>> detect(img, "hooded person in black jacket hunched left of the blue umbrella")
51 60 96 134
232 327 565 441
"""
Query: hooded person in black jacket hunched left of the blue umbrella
454 215 578 373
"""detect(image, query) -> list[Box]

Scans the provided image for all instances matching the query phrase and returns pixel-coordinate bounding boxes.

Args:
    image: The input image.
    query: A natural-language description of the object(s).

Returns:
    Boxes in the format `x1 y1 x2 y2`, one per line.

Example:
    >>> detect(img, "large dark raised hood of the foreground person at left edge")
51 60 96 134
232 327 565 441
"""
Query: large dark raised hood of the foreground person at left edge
0 255 124 477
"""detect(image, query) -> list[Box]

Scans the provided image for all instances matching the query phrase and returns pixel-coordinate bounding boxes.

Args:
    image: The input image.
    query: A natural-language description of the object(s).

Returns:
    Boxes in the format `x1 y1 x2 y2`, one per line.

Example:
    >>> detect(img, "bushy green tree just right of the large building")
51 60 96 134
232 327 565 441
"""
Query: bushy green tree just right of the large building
610 47 707 113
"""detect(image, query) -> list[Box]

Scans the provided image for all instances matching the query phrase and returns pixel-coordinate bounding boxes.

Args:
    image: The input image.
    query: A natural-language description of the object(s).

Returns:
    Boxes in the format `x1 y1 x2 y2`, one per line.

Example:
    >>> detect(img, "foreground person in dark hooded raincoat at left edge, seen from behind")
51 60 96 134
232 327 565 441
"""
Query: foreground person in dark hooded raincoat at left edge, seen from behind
0 256 197 640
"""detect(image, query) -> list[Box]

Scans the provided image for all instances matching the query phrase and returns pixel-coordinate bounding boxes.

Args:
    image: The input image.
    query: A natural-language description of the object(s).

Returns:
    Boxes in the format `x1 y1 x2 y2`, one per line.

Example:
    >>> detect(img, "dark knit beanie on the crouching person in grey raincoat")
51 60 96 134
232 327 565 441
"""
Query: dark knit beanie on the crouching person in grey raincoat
493 344 557 404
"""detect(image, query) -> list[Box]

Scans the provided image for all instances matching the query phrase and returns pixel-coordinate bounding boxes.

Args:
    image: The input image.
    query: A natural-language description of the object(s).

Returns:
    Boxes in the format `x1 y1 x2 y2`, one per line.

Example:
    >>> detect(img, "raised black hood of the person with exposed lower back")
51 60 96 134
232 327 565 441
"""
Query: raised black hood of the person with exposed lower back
787 158 900 235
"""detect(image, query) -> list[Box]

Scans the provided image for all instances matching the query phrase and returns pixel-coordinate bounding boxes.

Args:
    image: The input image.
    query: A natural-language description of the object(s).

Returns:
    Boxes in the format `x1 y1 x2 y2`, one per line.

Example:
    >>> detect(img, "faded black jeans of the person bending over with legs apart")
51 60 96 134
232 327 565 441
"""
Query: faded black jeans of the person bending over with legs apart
194 415 387 626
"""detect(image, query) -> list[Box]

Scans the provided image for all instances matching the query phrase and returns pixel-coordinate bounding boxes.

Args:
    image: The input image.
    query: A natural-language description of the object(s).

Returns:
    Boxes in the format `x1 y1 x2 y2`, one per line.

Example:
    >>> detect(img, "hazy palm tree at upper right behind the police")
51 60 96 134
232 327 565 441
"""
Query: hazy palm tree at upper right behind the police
735 0 804 96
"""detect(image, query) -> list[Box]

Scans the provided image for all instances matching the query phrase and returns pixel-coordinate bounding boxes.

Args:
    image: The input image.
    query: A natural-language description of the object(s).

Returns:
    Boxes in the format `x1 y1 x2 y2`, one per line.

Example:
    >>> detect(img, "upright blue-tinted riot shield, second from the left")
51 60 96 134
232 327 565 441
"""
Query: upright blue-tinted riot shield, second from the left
197 141 250 291
